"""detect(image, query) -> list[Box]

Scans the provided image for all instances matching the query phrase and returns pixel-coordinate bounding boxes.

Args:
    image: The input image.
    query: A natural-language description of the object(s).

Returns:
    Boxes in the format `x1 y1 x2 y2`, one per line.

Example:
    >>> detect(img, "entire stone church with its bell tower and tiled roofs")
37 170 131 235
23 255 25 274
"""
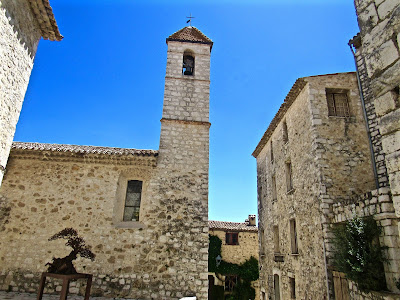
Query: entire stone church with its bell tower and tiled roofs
0 26 212 300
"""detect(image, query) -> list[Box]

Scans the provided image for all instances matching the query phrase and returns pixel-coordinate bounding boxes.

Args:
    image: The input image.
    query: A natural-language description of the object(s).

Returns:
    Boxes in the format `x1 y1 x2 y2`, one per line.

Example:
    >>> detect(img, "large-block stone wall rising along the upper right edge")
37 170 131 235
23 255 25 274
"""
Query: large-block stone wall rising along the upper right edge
354 0 400 260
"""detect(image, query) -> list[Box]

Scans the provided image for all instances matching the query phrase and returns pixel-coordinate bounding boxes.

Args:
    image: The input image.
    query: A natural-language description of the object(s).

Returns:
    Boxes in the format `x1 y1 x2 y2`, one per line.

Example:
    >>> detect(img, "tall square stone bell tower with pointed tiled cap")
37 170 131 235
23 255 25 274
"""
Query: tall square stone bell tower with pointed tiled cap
153 26 213 300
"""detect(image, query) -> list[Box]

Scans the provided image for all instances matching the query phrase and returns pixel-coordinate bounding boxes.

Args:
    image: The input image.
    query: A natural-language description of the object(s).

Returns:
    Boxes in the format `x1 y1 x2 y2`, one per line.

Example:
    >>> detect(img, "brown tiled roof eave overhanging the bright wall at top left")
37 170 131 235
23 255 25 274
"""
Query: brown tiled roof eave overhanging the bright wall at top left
29 0 63 41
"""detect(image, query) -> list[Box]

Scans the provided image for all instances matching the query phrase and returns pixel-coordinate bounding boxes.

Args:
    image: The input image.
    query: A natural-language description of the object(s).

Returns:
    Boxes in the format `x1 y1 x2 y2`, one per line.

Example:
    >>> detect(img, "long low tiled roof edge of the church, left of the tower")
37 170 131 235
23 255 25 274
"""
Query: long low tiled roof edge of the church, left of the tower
12 142 158 156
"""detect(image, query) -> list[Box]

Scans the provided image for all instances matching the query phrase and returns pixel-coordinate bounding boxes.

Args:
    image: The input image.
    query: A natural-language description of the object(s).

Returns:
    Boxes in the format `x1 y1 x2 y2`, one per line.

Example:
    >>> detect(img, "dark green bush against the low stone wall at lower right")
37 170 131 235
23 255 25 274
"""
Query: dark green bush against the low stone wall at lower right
333 217 386 291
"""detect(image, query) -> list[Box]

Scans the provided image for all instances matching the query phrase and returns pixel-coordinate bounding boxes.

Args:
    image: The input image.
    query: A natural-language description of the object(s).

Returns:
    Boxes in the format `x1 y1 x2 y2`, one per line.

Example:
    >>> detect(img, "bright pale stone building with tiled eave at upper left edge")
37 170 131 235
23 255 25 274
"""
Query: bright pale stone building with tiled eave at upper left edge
0 0 62 185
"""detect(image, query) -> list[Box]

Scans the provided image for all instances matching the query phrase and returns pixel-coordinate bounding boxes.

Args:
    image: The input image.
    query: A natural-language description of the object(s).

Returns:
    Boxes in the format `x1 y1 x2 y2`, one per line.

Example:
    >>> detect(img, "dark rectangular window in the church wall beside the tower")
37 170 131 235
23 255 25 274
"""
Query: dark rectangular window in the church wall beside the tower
124 180 142 221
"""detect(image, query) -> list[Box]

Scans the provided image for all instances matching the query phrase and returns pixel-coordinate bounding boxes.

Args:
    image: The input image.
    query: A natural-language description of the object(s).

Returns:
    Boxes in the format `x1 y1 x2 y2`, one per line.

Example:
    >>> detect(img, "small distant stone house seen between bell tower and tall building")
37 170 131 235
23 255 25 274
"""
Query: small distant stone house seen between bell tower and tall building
208 215 260 299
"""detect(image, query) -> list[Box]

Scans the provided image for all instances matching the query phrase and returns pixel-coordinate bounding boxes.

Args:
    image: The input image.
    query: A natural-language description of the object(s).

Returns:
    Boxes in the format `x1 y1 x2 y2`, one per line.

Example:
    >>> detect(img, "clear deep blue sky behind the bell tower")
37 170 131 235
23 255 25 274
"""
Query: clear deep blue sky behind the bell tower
15 0 358 222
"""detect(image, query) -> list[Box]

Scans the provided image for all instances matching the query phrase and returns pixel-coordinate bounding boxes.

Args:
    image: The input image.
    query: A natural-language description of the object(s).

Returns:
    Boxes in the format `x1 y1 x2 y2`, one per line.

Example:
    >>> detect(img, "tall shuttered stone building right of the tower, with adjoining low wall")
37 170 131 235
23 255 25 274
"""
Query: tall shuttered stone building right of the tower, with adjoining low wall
253 73 399 299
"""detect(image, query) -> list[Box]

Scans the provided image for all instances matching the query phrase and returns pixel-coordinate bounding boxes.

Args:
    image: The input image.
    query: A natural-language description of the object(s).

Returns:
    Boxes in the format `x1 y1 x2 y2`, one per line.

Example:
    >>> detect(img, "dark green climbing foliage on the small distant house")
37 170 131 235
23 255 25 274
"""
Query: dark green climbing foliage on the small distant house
208 235 260 300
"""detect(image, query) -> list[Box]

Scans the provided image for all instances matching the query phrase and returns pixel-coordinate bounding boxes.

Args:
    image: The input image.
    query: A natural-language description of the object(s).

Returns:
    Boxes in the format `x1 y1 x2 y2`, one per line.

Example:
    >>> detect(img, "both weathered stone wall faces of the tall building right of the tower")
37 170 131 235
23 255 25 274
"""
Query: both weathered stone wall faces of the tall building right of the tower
256 73 375 299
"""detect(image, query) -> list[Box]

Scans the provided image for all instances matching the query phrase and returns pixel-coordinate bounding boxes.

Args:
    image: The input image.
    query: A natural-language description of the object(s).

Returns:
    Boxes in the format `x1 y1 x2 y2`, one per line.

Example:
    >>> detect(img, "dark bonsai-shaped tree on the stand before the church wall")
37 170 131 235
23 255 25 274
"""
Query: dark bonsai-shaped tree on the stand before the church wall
46 228 96 275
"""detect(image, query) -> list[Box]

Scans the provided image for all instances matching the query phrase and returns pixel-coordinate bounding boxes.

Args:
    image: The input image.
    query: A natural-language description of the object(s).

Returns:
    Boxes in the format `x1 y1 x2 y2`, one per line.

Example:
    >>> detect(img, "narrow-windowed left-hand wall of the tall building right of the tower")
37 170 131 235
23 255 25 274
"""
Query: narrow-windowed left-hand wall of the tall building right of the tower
256 85 326 299
